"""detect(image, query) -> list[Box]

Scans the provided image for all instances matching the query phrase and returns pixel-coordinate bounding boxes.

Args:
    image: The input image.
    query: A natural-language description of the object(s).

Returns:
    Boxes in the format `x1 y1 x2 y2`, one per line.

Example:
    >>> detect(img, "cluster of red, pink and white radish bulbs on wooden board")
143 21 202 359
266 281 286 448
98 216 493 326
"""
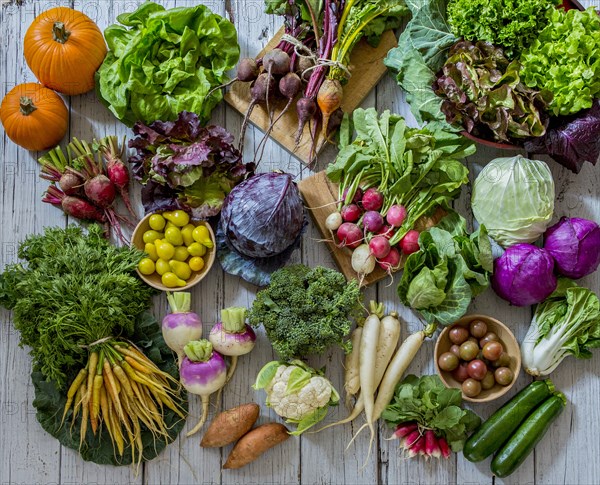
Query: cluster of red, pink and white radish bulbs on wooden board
325 188 419 276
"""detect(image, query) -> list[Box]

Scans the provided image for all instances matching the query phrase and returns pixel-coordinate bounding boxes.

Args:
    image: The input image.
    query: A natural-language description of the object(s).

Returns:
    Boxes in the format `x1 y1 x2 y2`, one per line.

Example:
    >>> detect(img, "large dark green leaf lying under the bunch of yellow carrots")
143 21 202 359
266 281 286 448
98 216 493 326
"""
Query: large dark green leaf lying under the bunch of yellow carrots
31 313 187 466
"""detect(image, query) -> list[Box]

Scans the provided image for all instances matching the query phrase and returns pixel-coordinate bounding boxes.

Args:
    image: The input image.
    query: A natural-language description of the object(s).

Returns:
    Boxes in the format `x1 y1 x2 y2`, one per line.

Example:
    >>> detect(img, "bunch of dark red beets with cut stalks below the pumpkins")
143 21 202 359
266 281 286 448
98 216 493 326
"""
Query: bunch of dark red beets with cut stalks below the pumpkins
38 136 135 244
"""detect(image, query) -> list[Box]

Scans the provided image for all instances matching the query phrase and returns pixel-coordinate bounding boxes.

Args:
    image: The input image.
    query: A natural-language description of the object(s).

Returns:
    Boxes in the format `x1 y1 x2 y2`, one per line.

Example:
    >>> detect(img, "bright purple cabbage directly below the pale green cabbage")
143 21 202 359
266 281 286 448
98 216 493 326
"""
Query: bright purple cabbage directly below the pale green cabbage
492 244 558 306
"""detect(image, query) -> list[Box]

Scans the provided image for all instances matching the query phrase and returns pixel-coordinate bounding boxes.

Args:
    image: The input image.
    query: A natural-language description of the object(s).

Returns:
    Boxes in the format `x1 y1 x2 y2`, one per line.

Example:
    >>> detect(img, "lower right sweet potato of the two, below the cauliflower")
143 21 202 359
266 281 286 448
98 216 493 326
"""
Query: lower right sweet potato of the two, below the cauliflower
223 423 290 468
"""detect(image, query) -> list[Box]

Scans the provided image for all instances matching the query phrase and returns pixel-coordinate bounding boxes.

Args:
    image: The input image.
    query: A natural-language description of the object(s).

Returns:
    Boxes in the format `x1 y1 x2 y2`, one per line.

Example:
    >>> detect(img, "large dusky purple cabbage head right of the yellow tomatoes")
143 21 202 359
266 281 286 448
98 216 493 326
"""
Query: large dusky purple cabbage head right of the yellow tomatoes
220 172 306 258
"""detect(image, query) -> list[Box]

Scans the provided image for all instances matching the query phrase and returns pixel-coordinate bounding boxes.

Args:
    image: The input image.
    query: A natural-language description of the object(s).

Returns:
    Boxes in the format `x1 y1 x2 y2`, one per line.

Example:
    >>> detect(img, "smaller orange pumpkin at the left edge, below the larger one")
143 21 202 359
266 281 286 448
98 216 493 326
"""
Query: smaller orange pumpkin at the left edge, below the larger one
0 83 69 151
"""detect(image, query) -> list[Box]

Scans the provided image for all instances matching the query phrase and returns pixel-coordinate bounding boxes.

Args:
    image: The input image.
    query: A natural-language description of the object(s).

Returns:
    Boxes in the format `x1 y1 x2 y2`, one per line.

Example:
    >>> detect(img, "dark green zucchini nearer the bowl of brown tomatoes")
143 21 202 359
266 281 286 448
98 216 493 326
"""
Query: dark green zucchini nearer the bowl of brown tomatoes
463 379 554 462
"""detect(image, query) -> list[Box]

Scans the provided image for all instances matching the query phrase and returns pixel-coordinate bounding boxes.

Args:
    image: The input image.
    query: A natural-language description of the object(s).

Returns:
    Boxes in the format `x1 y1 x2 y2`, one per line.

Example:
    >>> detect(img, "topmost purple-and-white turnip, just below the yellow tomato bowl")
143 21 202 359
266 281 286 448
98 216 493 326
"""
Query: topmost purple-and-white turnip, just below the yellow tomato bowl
162 291 202 366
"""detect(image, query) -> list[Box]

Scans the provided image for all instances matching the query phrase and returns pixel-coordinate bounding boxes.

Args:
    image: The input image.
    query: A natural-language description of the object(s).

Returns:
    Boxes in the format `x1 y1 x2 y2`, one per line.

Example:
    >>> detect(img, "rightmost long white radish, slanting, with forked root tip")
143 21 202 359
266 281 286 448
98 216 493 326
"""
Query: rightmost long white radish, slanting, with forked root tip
348 323 437 463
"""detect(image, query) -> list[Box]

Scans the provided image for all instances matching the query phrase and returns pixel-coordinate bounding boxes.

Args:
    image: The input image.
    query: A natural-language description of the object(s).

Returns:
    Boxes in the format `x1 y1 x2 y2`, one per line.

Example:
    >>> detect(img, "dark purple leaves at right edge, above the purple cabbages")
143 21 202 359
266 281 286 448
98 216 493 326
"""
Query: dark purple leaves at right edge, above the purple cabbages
525 100 600 173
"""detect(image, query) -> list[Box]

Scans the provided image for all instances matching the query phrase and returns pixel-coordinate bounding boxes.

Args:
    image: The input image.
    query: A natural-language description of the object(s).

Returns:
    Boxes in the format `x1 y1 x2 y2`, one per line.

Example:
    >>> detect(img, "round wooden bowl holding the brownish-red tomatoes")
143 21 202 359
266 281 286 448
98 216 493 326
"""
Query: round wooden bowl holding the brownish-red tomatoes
434 315 521 402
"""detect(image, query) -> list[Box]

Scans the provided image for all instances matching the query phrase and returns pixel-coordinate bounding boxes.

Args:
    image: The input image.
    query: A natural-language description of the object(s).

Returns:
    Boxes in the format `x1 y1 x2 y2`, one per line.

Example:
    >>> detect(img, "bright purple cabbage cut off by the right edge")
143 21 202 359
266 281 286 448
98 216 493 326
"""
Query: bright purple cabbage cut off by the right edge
544 217 600 279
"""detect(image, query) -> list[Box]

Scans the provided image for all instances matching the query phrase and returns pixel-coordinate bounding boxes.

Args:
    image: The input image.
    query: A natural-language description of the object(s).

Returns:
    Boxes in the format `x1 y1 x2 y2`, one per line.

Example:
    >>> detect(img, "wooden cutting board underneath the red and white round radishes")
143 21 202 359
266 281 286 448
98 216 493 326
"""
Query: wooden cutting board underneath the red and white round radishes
298 170 446 286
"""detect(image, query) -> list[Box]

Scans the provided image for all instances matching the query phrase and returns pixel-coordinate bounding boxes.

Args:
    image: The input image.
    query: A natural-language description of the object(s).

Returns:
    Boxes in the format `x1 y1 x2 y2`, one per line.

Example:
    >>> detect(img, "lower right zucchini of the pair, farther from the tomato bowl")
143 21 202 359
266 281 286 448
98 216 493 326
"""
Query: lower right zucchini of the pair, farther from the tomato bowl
491 393 567 478
